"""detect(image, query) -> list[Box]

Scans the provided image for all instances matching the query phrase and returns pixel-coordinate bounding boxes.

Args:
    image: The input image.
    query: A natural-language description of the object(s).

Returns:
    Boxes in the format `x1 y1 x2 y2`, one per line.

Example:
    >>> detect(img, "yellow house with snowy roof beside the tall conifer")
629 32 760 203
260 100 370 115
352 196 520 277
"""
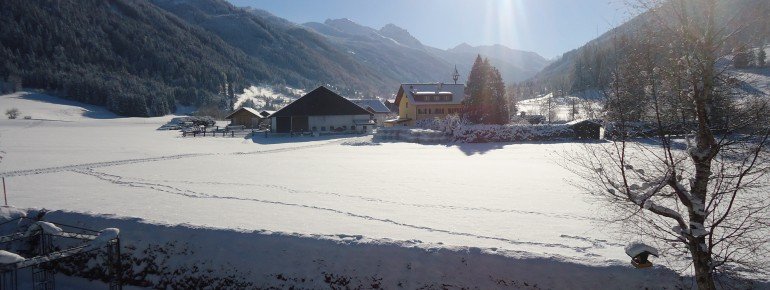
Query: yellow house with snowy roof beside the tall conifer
385 83 465 127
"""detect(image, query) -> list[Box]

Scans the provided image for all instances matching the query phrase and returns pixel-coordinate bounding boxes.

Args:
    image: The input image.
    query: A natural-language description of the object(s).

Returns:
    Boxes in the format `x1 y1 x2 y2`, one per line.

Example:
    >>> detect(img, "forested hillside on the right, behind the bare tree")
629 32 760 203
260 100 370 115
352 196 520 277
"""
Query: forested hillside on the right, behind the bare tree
516 0 770 98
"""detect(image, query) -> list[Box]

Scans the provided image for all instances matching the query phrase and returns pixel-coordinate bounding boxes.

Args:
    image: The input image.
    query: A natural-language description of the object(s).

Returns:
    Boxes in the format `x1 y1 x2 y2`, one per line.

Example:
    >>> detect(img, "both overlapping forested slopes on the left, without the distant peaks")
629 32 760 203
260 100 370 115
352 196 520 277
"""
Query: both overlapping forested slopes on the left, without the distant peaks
0 0 386 116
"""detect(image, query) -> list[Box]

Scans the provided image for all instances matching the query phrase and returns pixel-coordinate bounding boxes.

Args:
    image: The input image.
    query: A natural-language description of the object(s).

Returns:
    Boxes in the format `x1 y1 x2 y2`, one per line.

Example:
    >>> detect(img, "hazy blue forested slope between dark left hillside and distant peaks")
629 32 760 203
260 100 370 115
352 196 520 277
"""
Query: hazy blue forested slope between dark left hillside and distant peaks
150 0 394 95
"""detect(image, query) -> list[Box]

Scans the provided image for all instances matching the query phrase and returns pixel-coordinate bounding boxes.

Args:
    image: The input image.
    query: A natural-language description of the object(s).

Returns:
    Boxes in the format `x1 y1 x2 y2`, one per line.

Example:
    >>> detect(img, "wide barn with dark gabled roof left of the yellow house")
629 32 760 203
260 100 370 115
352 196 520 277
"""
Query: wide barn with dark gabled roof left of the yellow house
270 86 375 134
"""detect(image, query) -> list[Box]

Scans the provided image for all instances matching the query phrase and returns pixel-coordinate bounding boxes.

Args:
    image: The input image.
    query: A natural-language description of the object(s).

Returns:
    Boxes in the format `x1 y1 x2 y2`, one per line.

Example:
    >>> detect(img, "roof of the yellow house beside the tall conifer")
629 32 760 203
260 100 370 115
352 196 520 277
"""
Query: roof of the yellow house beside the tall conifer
396 83 465 105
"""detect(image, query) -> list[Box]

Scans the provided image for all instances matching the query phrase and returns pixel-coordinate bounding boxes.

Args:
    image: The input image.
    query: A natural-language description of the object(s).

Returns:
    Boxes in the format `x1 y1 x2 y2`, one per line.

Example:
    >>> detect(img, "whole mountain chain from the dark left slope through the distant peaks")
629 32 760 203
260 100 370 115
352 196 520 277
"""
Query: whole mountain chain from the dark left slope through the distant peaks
0 0 548 116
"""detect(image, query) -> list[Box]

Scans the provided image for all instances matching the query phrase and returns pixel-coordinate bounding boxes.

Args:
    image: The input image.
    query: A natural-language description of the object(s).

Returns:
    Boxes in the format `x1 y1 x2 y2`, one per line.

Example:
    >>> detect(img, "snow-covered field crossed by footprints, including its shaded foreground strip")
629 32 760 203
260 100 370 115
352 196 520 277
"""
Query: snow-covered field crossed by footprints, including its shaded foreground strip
0 93 764 289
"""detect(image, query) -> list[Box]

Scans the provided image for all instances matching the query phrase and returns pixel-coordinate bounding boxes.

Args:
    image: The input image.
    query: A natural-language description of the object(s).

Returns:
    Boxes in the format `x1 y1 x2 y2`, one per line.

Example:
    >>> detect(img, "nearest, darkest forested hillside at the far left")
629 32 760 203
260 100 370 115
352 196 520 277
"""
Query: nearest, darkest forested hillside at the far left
0 0 262 116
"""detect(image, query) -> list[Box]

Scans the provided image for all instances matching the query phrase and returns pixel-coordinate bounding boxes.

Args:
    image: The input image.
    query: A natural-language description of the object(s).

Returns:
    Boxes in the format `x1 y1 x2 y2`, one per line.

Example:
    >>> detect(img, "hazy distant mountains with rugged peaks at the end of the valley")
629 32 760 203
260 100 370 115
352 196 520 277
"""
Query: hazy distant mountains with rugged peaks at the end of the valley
303 18 549 83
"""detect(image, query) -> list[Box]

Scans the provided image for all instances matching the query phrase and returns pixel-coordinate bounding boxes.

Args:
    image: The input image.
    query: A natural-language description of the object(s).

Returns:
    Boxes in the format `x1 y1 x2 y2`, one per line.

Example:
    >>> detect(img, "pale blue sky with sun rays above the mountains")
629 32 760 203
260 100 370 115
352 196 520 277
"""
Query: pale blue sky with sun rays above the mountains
228 0 632 58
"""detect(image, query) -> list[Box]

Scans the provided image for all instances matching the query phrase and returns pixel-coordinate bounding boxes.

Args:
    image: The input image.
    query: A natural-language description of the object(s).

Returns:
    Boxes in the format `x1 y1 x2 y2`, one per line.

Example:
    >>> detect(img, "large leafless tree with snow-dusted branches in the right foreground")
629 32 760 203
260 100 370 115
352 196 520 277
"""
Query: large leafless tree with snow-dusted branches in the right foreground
570 0 770 289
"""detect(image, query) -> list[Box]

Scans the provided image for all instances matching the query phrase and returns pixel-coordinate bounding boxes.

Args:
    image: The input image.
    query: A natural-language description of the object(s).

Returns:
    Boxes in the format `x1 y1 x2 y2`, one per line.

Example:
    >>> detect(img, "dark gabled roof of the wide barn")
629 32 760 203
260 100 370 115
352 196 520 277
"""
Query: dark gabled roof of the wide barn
270 86 372 118
